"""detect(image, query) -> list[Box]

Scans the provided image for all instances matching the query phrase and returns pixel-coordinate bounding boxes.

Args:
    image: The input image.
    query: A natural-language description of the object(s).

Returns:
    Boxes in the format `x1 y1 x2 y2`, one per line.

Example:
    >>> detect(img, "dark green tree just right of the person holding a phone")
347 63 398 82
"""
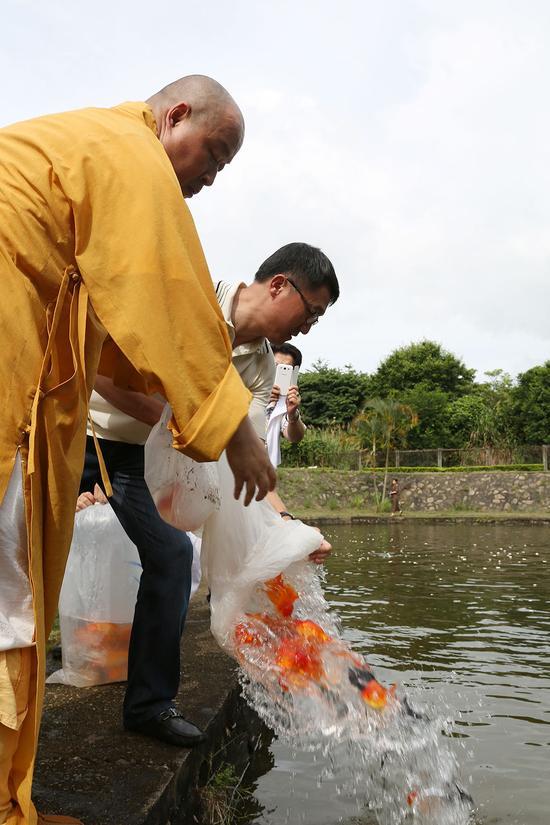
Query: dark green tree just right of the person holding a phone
300 361 370 427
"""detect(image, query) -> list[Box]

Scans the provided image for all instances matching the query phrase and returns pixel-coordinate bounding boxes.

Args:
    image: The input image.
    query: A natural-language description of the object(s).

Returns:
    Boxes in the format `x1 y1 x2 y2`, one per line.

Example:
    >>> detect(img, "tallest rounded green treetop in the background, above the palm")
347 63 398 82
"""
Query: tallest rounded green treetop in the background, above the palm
372 341 475 399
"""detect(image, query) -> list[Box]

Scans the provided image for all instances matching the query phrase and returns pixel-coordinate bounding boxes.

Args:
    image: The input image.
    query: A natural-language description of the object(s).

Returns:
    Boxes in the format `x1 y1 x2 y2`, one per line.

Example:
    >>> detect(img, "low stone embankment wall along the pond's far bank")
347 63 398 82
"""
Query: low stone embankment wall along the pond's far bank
279 468 550 514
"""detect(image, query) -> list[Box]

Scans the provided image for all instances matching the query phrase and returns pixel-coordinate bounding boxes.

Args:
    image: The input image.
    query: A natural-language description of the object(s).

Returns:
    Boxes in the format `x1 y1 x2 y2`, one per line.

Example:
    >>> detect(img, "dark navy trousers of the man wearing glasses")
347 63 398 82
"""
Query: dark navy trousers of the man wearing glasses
80 437 193 724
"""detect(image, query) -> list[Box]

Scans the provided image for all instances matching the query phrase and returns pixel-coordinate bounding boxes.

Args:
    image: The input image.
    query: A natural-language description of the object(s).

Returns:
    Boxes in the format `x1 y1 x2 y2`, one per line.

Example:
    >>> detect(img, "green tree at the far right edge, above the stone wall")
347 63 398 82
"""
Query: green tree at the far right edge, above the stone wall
512 361 550 444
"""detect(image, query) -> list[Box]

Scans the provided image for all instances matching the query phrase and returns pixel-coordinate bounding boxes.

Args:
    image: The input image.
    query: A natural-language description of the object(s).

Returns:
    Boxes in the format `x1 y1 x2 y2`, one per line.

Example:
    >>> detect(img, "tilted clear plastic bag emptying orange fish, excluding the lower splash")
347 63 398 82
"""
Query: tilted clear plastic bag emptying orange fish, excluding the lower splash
202 457 402 726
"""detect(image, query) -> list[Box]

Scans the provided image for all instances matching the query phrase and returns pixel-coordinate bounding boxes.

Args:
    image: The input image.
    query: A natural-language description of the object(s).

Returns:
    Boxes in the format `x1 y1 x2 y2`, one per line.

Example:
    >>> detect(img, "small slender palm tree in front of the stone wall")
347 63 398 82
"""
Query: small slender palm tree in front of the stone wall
352 398 418 507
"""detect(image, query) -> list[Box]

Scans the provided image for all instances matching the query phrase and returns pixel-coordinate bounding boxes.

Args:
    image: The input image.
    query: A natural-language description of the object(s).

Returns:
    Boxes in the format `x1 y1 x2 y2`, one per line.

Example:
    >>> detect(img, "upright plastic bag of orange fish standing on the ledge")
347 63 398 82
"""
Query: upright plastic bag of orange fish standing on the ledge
47 504 141 687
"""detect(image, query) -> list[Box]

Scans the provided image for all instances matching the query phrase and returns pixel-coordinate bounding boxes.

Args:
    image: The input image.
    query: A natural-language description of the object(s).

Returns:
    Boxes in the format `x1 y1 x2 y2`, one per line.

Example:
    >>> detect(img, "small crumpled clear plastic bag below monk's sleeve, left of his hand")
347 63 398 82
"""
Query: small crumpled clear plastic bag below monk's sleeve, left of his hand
145 404 220 531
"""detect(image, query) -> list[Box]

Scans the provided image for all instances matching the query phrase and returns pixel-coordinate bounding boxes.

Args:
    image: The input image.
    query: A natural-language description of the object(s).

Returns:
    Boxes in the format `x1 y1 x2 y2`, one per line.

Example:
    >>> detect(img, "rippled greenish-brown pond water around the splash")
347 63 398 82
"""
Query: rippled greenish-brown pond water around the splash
243 521 550 825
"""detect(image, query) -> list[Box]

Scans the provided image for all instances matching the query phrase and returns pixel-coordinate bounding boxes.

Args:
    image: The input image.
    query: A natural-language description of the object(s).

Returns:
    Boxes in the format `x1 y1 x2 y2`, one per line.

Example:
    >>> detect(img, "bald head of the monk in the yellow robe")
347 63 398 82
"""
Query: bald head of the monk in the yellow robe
147 75 248 198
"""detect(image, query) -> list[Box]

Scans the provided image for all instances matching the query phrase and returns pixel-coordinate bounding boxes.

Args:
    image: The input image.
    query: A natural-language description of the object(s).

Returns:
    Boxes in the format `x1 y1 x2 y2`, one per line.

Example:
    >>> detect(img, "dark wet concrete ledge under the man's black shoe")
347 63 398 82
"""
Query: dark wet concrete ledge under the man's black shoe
33 591 261 825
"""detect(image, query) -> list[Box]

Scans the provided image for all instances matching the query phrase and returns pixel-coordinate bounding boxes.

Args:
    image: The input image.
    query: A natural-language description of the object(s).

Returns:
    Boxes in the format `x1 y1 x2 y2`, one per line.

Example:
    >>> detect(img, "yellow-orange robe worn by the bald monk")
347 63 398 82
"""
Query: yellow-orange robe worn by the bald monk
0 103 250 825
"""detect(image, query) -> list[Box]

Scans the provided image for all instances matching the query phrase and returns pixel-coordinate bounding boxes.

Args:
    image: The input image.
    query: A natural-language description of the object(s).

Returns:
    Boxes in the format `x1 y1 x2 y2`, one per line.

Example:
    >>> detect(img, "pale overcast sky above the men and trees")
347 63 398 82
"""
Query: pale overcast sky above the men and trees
0 0 550 378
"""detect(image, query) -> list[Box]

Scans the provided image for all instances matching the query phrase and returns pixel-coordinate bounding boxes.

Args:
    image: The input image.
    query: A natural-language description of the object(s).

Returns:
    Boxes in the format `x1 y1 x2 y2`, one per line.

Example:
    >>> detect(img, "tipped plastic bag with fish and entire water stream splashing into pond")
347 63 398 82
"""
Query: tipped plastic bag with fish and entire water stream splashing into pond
202 457 470 825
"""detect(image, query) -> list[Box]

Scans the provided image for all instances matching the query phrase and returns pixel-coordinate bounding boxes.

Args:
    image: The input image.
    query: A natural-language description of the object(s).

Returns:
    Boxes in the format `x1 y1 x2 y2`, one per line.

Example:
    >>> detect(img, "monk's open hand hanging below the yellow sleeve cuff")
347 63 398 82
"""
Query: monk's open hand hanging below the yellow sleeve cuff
226 416 277 507
